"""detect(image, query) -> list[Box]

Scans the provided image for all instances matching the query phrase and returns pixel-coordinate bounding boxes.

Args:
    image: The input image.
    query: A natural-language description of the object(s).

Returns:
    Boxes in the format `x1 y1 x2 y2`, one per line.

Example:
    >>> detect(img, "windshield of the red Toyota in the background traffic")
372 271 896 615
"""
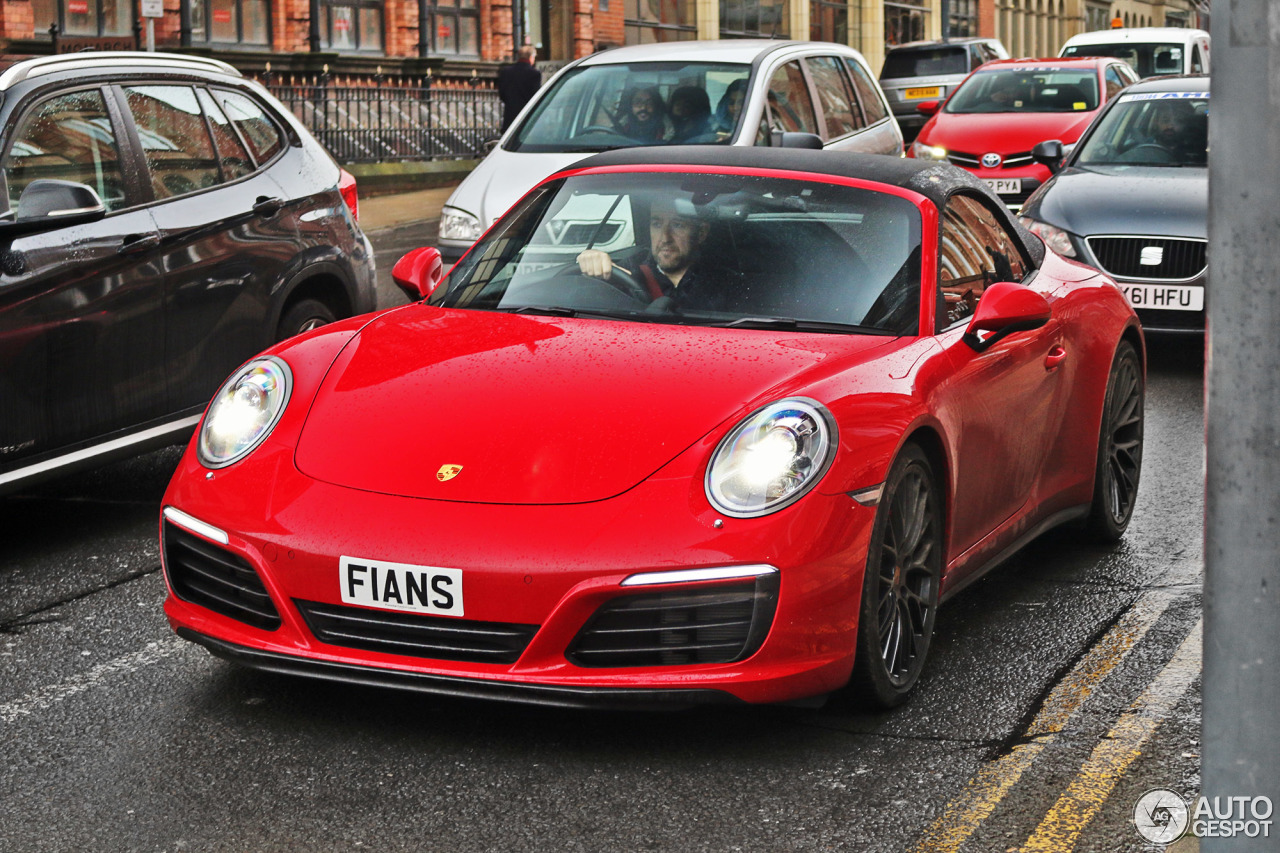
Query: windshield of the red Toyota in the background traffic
945 68 1098 113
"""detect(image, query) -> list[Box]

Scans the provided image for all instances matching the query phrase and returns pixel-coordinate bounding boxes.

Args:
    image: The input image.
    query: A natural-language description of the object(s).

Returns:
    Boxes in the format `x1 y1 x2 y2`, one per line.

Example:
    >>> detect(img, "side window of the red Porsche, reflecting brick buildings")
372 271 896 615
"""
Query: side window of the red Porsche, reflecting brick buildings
937 196 1027 330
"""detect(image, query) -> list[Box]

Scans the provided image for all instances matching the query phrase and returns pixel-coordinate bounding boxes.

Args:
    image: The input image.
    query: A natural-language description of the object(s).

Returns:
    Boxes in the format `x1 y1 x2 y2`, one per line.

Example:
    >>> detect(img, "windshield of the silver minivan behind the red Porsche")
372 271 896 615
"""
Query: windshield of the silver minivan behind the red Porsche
506 63 751 152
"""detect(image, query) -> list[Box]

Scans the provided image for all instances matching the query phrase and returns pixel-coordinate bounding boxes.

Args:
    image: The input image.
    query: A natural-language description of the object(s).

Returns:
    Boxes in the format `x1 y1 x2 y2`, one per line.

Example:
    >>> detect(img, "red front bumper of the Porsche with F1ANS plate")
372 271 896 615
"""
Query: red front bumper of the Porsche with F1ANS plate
161 446 874 707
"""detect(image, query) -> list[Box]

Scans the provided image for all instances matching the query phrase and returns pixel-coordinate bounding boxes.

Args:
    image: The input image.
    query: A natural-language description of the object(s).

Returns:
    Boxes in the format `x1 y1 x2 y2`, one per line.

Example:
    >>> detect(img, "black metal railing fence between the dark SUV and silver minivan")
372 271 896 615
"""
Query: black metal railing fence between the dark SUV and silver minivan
268 79 502 163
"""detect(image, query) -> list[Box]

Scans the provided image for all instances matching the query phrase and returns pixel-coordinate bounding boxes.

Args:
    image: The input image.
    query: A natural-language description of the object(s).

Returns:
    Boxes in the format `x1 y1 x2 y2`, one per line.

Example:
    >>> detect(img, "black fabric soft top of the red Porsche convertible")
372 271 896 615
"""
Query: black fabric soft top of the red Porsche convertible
571 145 1044 266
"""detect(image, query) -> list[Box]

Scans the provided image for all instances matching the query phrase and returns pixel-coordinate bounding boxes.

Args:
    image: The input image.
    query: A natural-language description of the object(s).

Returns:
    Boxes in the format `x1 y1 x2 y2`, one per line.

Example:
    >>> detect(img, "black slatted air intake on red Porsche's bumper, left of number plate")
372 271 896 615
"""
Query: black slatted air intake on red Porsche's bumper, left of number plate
164 521 280 631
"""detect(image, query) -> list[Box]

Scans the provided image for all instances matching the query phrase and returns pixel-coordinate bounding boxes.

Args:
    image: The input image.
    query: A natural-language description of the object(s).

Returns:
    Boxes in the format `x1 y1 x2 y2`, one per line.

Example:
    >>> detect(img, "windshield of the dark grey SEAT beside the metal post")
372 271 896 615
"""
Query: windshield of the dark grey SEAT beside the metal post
1075 92 1208 167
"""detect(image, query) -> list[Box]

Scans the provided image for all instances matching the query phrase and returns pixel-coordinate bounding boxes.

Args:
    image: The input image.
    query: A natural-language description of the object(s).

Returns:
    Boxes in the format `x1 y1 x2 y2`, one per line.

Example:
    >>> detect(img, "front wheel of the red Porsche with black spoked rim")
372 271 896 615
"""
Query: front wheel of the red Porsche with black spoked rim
850 444 943 708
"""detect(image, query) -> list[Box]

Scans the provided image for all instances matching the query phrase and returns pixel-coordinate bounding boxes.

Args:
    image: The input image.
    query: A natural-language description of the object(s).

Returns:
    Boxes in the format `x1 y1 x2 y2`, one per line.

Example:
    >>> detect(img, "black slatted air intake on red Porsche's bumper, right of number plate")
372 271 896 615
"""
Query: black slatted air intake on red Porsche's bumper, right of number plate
567 573 778 666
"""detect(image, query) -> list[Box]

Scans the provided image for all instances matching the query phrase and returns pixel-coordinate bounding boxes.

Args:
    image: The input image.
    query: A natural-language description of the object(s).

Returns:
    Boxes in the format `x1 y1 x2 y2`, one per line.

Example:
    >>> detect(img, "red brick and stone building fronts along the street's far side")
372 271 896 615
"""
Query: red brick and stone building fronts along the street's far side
0 0 1202 78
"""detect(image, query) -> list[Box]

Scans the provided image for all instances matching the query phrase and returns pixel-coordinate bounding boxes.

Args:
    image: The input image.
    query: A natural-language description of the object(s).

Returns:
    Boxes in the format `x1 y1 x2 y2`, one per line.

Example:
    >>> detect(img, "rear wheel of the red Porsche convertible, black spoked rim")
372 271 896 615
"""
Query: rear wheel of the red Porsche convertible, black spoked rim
1084 341 1144 542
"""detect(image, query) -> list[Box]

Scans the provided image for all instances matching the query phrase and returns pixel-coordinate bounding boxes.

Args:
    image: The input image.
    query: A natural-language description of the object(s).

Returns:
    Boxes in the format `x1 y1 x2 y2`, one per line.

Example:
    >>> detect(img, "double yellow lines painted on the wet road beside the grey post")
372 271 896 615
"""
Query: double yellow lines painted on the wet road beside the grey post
914 590 1201 853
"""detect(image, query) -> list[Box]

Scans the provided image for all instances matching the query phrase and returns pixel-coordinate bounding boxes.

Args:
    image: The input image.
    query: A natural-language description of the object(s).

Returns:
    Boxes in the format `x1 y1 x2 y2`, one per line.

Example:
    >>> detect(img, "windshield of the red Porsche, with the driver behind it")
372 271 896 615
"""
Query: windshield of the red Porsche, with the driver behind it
430 173 920 334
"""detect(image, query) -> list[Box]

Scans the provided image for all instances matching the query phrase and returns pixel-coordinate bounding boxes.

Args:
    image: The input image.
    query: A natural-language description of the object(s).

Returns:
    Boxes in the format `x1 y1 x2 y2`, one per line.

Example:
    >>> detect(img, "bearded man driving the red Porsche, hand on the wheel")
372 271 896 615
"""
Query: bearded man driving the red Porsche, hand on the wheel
577 197 735 311
